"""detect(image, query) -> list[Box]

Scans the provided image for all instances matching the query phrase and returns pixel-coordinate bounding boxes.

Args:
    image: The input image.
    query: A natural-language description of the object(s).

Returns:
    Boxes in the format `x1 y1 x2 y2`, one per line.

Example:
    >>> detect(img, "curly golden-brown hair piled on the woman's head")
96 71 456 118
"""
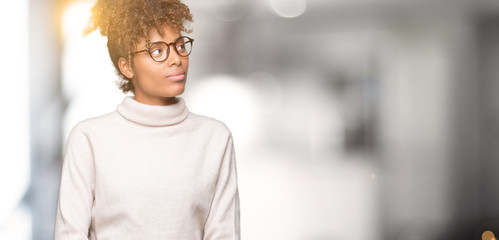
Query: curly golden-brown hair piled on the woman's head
84 0 193 93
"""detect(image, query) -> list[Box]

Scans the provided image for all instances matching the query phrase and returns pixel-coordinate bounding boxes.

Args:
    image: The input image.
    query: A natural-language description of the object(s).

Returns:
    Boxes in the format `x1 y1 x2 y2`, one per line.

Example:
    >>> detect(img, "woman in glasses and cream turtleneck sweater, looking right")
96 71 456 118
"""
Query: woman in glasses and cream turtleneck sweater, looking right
55 0 240 240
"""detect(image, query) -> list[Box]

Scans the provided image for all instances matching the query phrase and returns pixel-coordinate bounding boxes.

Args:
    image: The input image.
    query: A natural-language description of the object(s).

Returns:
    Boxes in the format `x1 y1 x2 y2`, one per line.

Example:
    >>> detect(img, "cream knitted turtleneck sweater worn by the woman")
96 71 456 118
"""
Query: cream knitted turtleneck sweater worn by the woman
55 97 240 240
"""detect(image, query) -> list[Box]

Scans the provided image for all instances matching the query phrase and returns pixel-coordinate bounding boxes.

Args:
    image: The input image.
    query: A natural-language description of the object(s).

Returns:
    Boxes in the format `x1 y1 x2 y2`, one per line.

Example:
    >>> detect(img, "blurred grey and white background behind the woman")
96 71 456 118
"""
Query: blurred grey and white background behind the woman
0 0 499 240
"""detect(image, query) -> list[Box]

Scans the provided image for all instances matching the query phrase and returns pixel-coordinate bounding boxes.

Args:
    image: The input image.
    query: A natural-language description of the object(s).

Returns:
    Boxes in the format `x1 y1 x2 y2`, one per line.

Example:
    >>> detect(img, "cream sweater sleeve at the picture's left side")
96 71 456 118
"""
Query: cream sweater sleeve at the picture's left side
54 128 95 240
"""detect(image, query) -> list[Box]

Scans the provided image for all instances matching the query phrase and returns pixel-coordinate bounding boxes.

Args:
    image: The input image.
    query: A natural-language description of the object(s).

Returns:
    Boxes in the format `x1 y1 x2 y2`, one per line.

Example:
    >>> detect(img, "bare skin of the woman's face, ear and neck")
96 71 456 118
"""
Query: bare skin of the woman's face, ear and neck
118 25 189 105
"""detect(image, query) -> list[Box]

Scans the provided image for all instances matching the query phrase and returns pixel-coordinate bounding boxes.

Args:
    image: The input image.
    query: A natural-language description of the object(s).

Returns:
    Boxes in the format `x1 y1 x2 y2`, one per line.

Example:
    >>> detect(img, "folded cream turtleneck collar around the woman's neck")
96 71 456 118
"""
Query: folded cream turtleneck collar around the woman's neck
116 96 188 127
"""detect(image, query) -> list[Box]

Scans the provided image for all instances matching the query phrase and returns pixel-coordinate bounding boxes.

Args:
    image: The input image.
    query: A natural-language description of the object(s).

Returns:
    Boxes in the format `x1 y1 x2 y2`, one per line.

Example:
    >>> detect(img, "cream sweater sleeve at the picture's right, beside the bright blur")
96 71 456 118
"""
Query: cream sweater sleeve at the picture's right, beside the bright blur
204 134 240 240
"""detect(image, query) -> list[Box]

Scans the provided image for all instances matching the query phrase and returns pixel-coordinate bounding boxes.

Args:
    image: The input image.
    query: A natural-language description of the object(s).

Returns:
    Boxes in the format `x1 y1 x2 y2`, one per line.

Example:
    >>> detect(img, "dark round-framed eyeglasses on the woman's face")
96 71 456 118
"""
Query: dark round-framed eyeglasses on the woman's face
130 36 194 62
